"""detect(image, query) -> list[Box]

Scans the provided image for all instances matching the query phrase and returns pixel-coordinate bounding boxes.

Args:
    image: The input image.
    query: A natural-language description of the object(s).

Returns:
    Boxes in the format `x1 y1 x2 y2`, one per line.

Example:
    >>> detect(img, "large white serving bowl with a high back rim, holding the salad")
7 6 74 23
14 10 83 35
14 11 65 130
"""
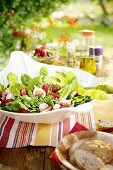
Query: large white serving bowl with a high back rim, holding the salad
0 51 100 123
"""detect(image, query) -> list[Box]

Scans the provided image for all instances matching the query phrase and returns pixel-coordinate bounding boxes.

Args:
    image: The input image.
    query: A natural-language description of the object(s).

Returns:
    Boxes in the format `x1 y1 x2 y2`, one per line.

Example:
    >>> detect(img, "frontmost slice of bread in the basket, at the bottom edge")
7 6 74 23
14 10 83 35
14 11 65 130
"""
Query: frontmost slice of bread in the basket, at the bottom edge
73 149 105 170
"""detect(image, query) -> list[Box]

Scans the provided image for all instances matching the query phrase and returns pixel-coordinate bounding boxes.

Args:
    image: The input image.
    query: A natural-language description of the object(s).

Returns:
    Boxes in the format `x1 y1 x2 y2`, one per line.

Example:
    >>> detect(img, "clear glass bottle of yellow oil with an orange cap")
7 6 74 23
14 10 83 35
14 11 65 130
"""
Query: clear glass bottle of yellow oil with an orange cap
80 30 96 75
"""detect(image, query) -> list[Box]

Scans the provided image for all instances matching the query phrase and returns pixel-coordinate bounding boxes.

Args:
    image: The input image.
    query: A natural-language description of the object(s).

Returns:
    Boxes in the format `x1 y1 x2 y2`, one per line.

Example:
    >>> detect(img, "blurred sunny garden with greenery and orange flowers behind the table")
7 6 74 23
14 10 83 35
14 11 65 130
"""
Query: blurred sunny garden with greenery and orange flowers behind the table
0 0 113 70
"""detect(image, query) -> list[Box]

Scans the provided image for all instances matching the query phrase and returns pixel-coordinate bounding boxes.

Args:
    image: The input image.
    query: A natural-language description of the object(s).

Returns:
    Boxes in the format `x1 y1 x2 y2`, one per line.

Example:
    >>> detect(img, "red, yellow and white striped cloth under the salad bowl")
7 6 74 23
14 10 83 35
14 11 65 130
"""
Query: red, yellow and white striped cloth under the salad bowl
0 111 95 148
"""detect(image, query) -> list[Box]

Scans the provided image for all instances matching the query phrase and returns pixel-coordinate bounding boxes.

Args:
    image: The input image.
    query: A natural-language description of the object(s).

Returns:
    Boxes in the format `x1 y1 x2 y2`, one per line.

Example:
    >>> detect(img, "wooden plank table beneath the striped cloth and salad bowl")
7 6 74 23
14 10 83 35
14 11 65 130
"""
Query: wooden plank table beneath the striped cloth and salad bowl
0 55 113 170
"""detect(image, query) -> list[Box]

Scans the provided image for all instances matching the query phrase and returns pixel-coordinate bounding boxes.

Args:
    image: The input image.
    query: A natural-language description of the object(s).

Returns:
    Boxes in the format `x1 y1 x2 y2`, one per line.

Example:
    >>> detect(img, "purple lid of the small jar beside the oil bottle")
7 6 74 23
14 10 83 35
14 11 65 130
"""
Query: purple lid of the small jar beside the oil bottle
89 45 103 56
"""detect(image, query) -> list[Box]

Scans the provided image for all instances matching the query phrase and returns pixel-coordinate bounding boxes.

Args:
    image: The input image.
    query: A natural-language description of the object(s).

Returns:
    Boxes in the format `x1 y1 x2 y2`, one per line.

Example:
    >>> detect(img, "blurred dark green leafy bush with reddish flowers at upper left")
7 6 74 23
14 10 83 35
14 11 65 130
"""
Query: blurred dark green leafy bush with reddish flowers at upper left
0 0 72 57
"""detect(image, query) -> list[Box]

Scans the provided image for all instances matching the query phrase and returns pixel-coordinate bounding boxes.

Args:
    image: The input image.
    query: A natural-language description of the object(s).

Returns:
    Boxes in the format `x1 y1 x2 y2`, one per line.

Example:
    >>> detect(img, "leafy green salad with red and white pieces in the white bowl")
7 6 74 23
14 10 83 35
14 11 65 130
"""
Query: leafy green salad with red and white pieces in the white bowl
0 67 107 113
